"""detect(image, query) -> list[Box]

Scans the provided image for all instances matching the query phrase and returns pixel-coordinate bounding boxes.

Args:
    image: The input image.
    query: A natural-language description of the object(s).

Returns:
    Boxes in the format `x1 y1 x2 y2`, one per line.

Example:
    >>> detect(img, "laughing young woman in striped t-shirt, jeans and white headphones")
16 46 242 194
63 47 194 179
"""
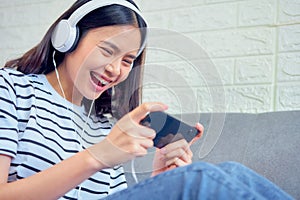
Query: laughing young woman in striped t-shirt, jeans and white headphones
0 0 288 199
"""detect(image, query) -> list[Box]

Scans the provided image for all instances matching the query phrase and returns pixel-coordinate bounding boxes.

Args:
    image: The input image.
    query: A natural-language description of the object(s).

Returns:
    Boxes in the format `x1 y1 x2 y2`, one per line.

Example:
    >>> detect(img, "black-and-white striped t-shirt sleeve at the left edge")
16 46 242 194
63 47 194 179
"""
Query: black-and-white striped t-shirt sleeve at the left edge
0 69 18 157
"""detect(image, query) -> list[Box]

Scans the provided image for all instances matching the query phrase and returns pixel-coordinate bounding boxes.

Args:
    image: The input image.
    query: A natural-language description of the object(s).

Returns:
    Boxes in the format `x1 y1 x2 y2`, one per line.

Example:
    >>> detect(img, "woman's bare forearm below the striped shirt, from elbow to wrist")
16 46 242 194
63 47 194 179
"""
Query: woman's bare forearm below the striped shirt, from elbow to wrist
0 151 104 200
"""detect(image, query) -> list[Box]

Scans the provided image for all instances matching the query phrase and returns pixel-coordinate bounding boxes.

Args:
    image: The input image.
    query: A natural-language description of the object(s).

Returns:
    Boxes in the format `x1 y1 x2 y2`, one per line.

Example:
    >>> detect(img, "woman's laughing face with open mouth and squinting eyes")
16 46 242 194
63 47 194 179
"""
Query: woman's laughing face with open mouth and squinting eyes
61 25 141 105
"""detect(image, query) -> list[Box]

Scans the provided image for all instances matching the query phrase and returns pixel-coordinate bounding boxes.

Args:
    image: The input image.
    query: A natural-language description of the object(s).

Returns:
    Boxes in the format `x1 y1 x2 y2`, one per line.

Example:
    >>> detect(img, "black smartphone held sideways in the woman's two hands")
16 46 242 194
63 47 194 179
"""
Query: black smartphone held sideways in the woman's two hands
141 111 199 148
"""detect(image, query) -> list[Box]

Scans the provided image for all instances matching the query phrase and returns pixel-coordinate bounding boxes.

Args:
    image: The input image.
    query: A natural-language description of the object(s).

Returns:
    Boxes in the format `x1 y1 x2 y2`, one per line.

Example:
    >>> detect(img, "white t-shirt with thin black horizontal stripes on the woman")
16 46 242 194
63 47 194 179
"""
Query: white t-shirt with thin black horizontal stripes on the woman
0 69 127 199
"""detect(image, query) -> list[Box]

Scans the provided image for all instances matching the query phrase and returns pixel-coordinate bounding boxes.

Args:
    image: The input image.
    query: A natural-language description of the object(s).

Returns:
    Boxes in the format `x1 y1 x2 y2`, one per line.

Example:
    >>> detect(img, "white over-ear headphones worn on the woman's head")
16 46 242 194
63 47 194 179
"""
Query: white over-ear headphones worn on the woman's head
51 0 146 53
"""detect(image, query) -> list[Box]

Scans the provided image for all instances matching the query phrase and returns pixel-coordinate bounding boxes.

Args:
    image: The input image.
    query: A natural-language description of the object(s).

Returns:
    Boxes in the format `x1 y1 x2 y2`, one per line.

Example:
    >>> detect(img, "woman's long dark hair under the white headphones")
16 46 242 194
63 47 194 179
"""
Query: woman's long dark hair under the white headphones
4 0 146 118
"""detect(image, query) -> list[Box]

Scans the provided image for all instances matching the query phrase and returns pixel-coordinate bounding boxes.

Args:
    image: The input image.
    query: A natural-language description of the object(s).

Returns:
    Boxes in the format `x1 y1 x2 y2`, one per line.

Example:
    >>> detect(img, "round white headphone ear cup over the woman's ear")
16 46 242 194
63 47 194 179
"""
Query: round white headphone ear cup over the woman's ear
51 19 78 53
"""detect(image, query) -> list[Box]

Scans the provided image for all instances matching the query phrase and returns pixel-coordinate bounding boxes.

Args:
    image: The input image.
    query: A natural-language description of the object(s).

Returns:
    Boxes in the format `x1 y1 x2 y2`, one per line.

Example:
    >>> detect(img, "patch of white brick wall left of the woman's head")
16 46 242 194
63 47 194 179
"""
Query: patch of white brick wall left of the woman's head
0 0 74 65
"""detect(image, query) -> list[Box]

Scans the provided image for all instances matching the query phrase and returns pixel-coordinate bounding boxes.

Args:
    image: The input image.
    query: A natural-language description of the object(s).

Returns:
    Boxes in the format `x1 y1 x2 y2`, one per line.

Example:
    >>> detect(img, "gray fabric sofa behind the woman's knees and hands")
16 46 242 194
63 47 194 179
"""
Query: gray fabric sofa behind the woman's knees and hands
125 111 300 199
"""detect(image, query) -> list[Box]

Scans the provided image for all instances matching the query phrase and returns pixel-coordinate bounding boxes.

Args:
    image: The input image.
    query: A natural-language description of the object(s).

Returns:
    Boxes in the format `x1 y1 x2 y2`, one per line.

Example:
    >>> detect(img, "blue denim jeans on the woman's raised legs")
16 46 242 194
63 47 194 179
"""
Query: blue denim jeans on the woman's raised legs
105 162 292 200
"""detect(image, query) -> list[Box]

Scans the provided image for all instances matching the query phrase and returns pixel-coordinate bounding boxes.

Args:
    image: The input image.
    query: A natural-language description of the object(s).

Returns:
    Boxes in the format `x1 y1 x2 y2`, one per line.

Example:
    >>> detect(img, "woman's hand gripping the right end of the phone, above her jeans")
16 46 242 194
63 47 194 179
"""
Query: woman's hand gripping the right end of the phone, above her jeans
152 123 203 176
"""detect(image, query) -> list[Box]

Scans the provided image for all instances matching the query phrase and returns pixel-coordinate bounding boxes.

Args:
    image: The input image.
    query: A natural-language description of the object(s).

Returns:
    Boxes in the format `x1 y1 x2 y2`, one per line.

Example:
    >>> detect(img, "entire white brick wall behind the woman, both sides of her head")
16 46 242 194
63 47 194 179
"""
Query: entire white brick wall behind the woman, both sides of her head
0 0 300 113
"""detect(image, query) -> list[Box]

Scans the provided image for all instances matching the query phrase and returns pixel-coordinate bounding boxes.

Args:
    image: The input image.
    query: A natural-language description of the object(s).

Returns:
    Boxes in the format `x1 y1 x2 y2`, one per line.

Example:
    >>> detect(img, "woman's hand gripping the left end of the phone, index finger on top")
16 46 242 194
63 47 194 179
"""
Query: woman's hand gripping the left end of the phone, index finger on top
87 102 167 168
